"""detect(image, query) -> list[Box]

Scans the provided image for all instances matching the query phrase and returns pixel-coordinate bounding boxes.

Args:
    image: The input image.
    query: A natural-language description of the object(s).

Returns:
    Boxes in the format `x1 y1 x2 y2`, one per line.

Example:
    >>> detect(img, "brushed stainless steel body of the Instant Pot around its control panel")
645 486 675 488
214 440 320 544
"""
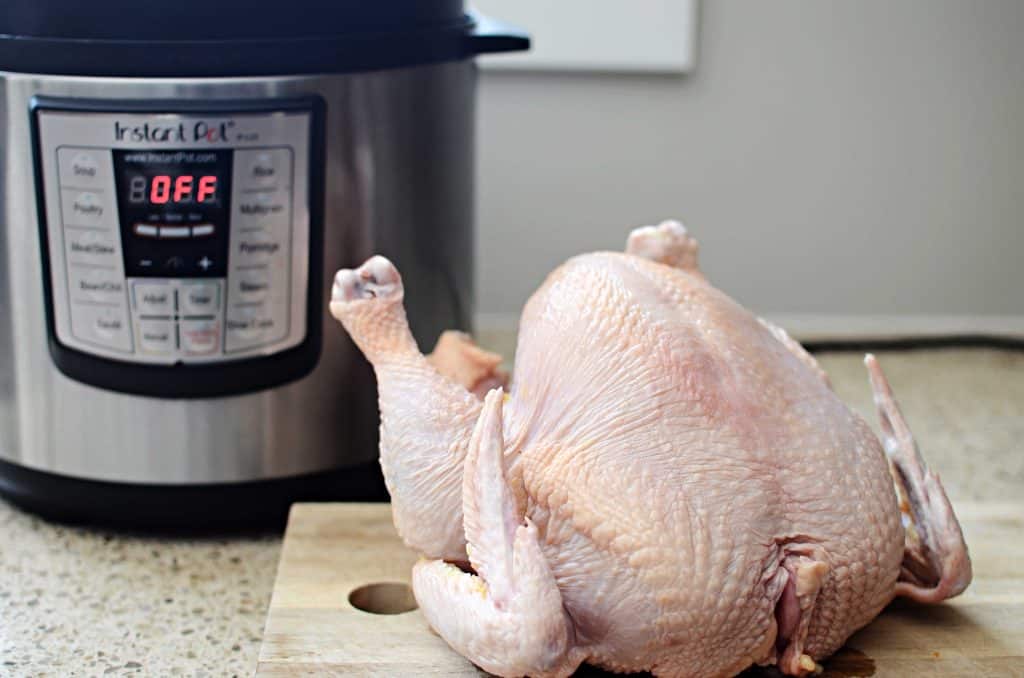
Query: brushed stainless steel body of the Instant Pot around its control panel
0 60 476 484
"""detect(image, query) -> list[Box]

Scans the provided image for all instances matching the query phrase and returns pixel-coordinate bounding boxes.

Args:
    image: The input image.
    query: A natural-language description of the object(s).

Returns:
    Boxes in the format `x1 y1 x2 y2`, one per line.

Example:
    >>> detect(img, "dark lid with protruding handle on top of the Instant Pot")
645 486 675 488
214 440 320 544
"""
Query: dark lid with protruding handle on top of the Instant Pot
0 0 529 77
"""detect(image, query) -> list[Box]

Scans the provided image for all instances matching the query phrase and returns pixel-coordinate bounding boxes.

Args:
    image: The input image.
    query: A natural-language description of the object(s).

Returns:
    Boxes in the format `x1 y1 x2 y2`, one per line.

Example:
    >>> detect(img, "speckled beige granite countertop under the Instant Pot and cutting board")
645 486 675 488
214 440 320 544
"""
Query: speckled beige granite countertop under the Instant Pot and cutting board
0 348 1024 676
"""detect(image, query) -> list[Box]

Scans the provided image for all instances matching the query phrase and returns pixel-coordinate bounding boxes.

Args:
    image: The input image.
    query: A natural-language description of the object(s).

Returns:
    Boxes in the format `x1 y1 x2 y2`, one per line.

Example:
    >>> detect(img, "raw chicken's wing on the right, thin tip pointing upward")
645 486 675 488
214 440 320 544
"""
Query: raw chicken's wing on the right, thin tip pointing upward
864 353 971 602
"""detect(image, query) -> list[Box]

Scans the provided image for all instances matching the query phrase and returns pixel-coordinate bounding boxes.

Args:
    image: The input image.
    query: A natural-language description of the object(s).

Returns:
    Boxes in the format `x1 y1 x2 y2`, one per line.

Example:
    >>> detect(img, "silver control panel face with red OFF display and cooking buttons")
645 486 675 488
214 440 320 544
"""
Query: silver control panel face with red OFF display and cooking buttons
38 110 312 365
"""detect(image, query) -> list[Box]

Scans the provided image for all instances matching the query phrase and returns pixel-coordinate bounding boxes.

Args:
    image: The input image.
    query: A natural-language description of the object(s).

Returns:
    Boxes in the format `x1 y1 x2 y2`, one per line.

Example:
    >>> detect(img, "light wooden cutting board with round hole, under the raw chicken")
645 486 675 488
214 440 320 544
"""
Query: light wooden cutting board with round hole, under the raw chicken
256 503 1024 677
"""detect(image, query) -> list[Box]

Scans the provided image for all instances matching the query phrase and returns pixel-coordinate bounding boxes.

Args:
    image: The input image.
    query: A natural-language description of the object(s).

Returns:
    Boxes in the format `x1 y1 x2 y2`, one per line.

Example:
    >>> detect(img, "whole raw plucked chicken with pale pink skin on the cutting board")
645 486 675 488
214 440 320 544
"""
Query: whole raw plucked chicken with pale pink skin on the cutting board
331 221 971 676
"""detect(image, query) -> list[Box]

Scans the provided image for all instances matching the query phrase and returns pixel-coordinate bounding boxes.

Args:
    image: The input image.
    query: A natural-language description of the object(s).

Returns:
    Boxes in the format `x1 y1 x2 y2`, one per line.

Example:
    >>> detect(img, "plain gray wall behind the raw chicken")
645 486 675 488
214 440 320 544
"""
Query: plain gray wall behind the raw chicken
477 0 1024 327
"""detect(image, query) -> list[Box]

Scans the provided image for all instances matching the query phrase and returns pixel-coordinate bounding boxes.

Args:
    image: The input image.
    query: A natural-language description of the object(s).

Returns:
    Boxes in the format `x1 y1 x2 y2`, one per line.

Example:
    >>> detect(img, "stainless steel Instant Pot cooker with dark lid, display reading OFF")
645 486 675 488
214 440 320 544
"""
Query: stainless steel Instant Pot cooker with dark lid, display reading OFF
0 0 528 524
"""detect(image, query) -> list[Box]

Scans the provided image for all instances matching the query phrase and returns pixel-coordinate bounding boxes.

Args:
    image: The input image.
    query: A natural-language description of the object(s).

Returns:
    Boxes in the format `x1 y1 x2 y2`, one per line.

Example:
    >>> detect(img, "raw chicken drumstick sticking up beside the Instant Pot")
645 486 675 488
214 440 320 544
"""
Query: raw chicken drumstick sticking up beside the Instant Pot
331 256 480 561
